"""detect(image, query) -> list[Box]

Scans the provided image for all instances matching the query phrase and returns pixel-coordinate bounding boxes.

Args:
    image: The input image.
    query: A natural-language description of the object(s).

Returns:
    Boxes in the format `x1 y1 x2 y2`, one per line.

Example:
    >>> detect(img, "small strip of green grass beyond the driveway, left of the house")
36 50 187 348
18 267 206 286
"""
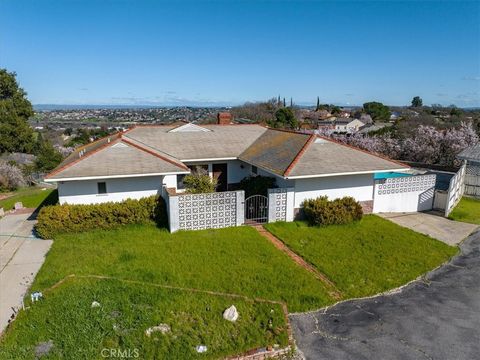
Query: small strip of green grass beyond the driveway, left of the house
0 187 58 211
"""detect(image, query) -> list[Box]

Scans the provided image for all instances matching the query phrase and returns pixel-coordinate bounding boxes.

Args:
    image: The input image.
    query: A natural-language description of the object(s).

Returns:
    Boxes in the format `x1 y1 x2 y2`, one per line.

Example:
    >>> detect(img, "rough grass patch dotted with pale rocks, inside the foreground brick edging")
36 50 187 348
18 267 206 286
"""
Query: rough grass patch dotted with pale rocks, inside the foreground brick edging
0 279 288 360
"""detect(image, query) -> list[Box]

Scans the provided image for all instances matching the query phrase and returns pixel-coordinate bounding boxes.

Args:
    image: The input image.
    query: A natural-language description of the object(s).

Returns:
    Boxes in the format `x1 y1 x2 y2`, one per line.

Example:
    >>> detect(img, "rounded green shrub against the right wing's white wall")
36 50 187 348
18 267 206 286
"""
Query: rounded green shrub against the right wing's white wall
301 196 363 225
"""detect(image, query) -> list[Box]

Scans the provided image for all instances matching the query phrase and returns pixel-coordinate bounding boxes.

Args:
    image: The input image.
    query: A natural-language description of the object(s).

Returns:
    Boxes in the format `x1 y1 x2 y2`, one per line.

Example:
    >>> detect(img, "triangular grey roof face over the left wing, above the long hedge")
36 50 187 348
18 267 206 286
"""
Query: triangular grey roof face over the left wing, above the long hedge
48 140 188 180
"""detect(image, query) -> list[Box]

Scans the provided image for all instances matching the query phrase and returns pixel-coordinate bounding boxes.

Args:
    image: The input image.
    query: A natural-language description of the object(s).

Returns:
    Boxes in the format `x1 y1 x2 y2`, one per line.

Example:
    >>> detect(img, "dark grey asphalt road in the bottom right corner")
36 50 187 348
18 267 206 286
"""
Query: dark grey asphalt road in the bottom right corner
291 231 480 360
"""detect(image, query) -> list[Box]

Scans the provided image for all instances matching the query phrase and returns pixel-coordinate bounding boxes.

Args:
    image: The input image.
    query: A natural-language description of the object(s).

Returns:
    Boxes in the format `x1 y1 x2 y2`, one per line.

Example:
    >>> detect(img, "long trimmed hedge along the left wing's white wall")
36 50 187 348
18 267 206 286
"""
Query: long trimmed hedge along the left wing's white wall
35 196 167 239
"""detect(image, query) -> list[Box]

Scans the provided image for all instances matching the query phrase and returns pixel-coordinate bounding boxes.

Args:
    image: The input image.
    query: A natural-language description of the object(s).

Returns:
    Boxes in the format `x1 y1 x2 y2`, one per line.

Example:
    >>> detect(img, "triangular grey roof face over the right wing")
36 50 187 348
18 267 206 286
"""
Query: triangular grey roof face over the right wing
288 138 408 177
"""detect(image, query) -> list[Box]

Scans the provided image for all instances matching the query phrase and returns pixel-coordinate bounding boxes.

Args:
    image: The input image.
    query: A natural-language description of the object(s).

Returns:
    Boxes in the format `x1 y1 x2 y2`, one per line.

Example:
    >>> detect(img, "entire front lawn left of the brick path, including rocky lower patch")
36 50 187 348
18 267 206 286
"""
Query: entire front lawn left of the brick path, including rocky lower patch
0 225 333 359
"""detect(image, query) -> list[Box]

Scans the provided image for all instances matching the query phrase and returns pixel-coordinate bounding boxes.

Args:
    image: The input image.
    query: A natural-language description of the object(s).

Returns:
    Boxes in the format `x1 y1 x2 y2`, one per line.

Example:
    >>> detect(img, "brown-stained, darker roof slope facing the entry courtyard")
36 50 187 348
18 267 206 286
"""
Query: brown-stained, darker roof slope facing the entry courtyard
238 129 310 175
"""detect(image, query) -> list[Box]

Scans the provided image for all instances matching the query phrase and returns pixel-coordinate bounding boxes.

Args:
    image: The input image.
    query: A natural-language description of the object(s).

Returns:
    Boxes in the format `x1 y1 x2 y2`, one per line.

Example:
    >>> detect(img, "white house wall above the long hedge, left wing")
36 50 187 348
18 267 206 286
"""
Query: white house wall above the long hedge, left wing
58 176 163 204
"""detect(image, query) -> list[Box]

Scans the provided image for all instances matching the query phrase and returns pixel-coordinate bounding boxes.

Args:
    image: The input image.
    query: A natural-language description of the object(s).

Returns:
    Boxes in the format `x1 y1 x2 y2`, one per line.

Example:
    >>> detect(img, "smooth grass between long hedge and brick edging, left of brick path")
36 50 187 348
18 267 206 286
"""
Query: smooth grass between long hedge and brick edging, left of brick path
32 225 332 311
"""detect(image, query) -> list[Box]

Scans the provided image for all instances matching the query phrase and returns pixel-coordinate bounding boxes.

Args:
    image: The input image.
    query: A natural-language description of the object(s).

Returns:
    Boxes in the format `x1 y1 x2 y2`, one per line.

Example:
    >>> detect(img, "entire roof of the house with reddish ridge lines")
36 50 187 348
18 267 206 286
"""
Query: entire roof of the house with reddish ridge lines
47 123 407 181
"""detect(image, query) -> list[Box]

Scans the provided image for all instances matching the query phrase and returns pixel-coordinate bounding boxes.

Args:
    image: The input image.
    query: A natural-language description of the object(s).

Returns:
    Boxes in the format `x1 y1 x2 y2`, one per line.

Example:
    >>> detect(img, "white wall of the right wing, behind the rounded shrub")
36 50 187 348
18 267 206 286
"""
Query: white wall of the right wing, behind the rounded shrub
294 174 374 208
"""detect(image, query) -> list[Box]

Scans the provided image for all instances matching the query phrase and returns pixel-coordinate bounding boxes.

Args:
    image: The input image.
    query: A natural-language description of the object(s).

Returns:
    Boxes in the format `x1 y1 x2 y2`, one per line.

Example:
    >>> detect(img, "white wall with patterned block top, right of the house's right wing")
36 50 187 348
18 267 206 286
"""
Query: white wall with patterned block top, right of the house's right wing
373 174 436 213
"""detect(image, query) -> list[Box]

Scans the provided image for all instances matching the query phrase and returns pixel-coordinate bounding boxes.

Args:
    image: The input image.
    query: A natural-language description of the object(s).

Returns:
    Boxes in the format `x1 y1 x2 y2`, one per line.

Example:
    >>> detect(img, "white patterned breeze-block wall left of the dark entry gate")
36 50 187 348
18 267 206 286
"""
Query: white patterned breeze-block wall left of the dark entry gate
164 190 245 232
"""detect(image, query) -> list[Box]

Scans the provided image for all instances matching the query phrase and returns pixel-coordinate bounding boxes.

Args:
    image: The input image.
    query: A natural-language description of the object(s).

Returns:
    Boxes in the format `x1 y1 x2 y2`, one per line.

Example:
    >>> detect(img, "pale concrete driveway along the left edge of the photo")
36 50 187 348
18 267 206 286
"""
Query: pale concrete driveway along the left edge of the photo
0 214 52 333
